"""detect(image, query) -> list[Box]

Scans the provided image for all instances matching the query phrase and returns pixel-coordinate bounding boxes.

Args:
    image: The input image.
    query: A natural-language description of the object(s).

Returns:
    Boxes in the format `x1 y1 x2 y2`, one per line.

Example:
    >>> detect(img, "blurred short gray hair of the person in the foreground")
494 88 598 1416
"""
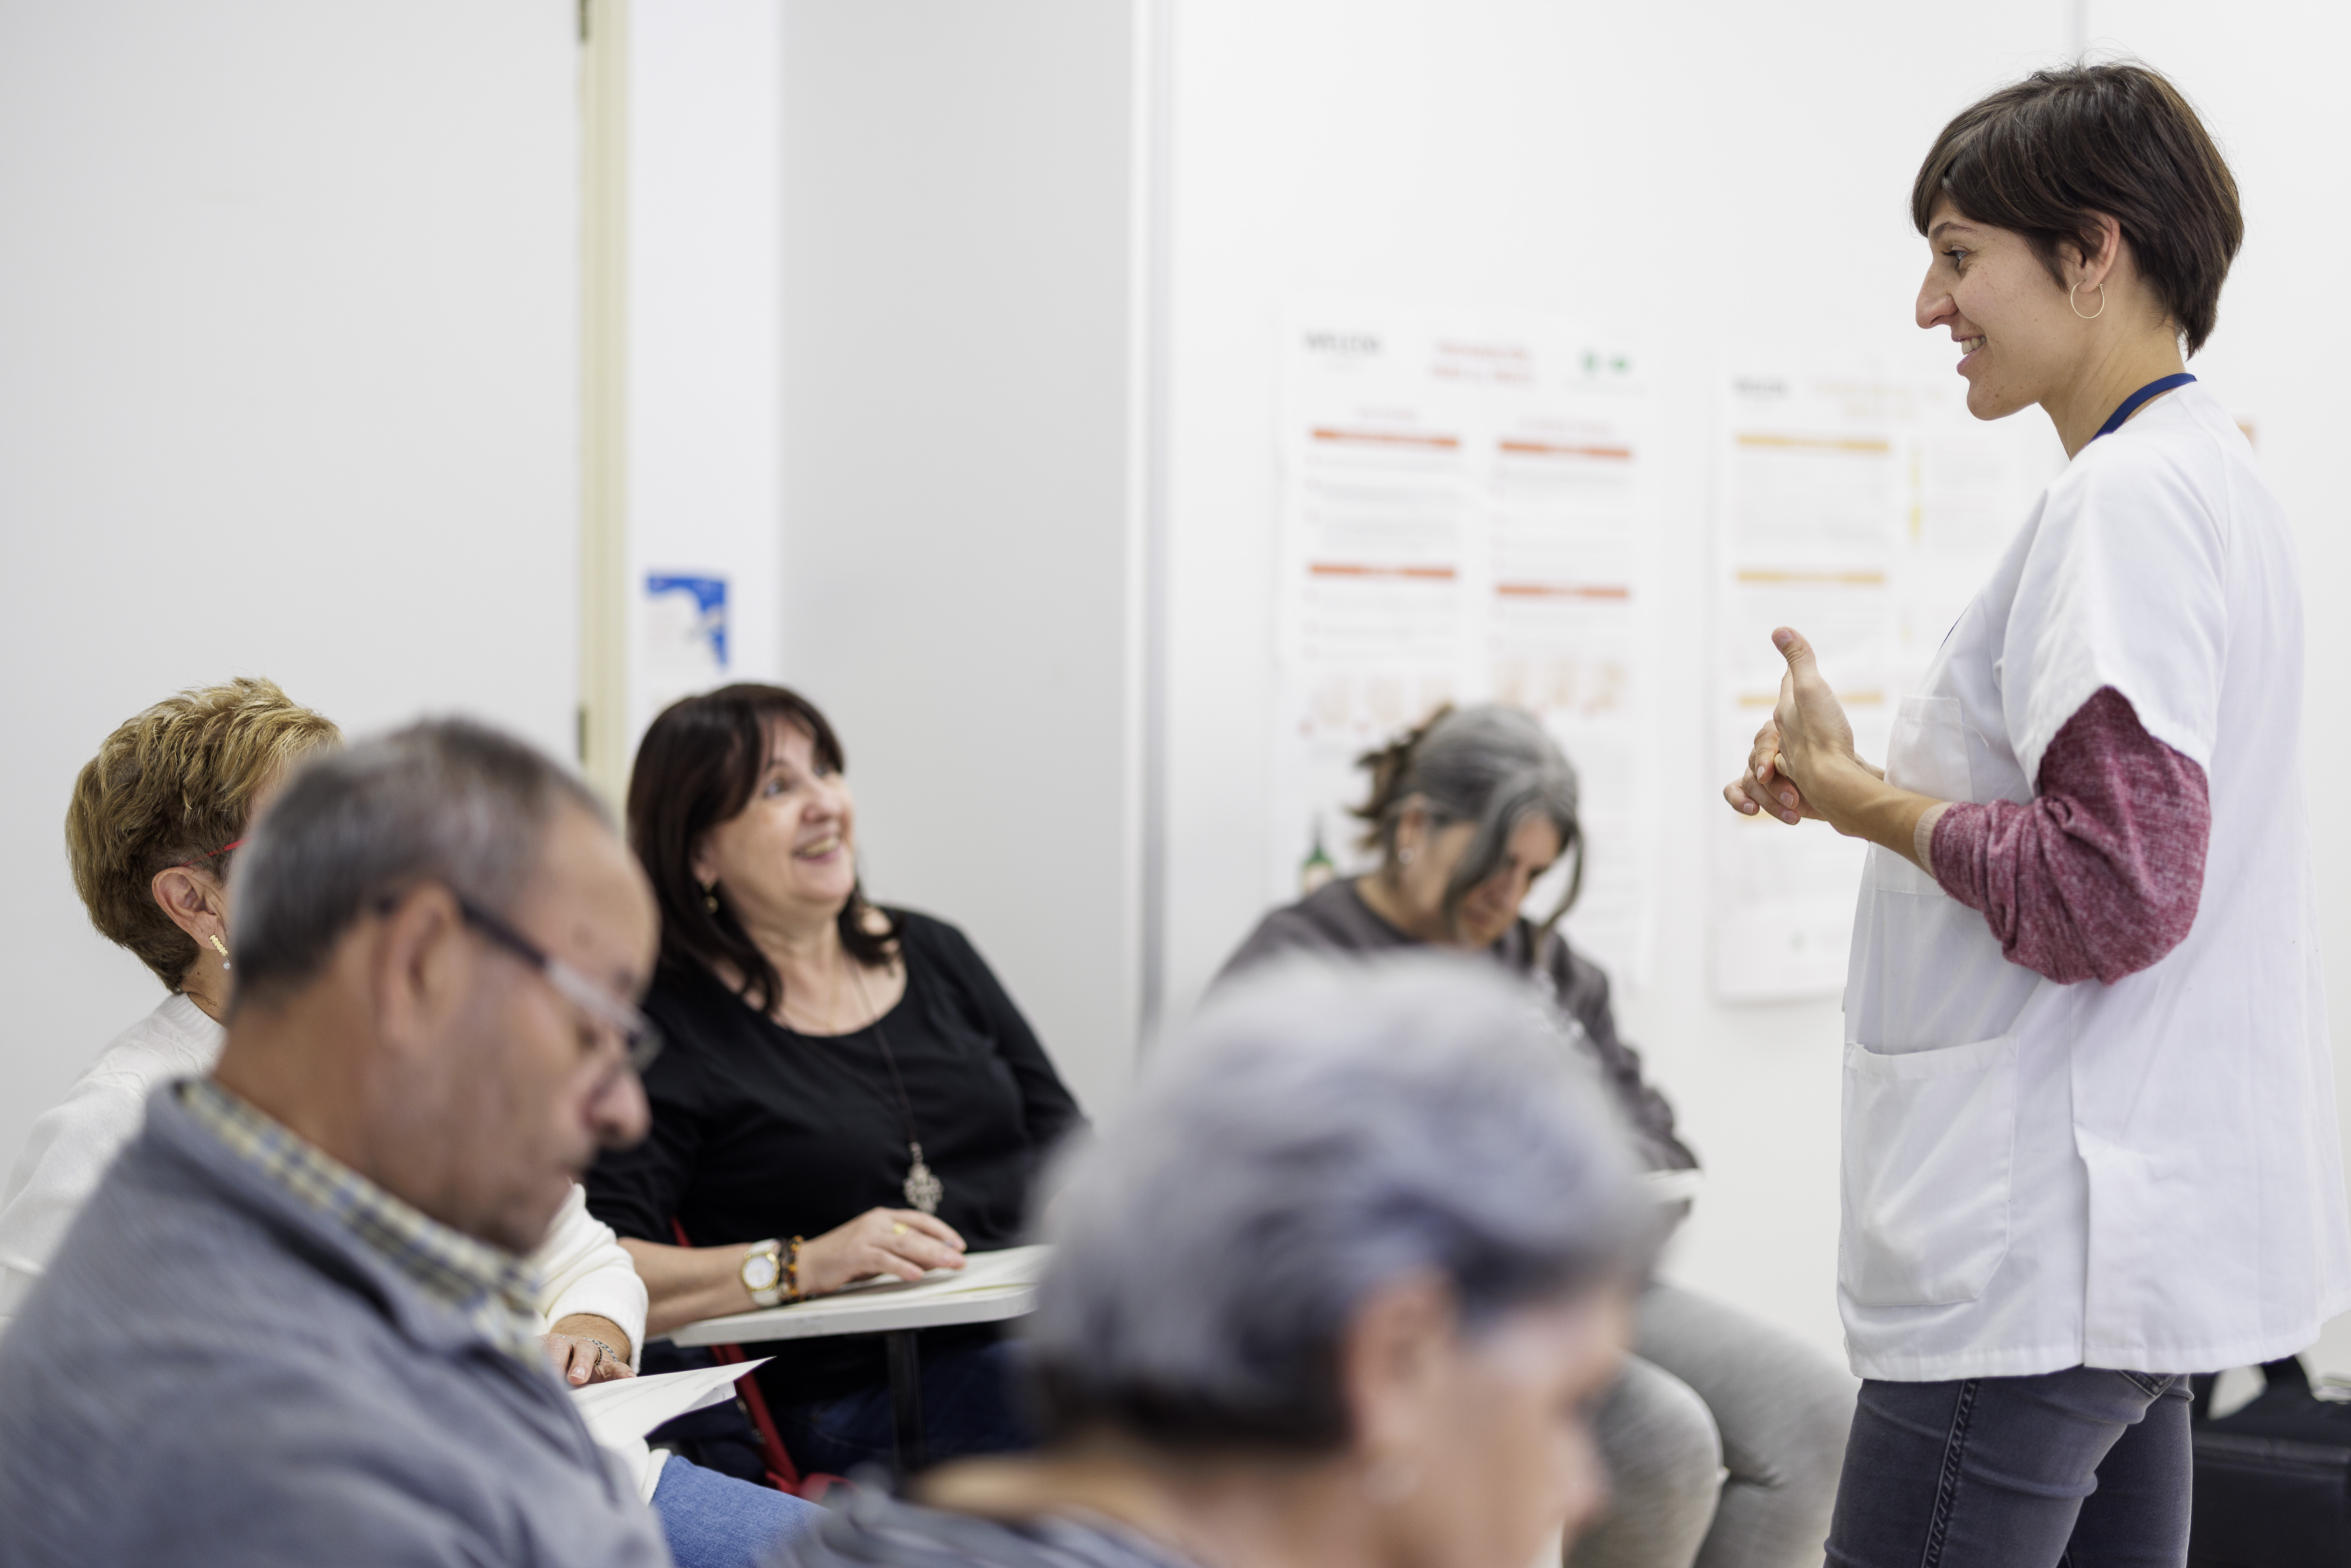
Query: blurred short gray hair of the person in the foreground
1027 954 1660 1453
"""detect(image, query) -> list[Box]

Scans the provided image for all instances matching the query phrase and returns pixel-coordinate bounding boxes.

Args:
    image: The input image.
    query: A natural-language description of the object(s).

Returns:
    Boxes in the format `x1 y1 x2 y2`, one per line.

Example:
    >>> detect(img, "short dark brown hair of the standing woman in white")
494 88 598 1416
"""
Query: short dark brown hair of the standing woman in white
1911 63 2245 353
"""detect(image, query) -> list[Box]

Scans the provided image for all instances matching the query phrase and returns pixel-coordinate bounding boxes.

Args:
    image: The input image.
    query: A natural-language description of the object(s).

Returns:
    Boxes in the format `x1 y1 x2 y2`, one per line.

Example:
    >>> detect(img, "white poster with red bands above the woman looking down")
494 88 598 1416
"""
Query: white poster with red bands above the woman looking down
1265 306 1655 983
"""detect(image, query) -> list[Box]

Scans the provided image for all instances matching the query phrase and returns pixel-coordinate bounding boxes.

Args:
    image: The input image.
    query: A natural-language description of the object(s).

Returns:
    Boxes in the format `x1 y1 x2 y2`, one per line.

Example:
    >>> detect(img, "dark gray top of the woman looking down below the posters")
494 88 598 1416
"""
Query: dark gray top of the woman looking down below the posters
1218 879 1697 1171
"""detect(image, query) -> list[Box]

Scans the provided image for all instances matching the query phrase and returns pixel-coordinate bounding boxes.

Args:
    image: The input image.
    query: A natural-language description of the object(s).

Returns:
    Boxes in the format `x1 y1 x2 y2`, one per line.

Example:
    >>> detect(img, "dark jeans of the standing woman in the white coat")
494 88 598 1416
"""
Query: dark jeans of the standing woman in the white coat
1829 1366 2191 1568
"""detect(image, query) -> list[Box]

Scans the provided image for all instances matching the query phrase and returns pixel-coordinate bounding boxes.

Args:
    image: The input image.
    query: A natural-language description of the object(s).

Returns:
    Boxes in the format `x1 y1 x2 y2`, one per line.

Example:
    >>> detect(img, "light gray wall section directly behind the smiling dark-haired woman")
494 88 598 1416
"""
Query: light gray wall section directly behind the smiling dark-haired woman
783 0 1138 1112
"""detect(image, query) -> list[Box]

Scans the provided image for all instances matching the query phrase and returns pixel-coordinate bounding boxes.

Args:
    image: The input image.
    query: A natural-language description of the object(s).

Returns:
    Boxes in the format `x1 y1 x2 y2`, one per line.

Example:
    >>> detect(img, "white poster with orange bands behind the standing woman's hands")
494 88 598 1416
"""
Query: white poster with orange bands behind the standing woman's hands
1709 369 2062 1001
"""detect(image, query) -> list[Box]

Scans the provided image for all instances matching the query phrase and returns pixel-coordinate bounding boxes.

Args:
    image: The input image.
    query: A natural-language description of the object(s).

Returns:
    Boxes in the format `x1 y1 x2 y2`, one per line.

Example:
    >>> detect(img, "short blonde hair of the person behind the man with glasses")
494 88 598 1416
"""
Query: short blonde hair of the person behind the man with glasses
66 675 343 990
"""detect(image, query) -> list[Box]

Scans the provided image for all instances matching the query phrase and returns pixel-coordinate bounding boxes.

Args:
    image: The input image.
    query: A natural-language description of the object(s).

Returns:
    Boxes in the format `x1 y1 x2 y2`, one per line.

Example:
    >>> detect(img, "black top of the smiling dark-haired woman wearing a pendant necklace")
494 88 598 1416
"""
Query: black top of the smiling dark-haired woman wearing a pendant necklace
585 910 1084 1403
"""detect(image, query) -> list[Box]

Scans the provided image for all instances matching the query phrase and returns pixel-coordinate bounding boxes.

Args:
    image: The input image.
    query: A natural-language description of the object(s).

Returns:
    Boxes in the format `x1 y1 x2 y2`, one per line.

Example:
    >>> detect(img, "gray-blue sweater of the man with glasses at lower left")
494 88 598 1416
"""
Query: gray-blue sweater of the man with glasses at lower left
0 1088 670 1568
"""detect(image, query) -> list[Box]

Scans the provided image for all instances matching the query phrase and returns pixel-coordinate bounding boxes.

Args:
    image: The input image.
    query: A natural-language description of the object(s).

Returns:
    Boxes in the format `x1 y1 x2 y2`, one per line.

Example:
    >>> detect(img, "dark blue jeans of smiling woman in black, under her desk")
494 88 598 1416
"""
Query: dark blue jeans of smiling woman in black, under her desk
769 1340 1037 1476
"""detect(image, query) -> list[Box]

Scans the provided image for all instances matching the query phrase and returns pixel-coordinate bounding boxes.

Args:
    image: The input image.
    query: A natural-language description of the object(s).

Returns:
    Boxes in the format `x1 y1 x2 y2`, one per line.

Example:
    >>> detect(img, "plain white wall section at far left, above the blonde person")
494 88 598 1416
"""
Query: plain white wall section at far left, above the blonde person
0 0 578 1166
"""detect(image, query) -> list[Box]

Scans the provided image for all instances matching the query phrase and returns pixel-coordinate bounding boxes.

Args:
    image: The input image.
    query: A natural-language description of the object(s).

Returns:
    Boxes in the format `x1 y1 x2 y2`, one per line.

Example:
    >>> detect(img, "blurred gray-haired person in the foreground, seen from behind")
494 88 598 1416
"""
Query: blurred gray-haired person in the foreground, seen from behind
788 957 1657 1568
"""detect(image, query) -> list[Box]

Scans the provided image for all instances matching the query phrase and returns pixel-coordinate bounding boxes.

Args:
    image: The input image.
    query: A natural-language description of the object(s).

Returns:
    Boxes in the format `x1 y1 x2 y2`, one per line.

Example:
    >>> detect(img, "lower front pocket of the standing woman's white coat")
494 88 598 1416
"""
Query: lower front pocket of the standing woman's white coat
1836 1034 2017 1307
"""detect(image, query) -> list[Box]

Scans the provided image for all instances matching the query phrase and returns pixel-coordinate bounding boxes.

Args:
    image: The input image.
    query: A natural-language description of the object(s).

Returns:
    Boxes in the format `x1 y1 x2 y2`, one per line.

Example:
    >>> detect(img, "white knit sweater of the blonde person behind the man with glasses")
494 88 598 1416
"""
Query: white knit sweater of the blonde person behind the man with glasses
0 994 644 1359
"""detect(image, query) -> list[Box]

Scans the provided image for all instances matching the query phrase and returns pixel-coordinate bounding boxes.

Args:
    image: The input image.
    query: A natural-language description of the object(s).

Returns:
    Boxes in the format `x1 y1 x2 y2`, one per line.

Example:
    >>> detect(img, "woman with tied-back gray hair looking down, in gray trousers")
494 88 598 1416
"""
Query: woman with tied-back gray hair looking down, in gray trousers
1225 705 1855 1568
